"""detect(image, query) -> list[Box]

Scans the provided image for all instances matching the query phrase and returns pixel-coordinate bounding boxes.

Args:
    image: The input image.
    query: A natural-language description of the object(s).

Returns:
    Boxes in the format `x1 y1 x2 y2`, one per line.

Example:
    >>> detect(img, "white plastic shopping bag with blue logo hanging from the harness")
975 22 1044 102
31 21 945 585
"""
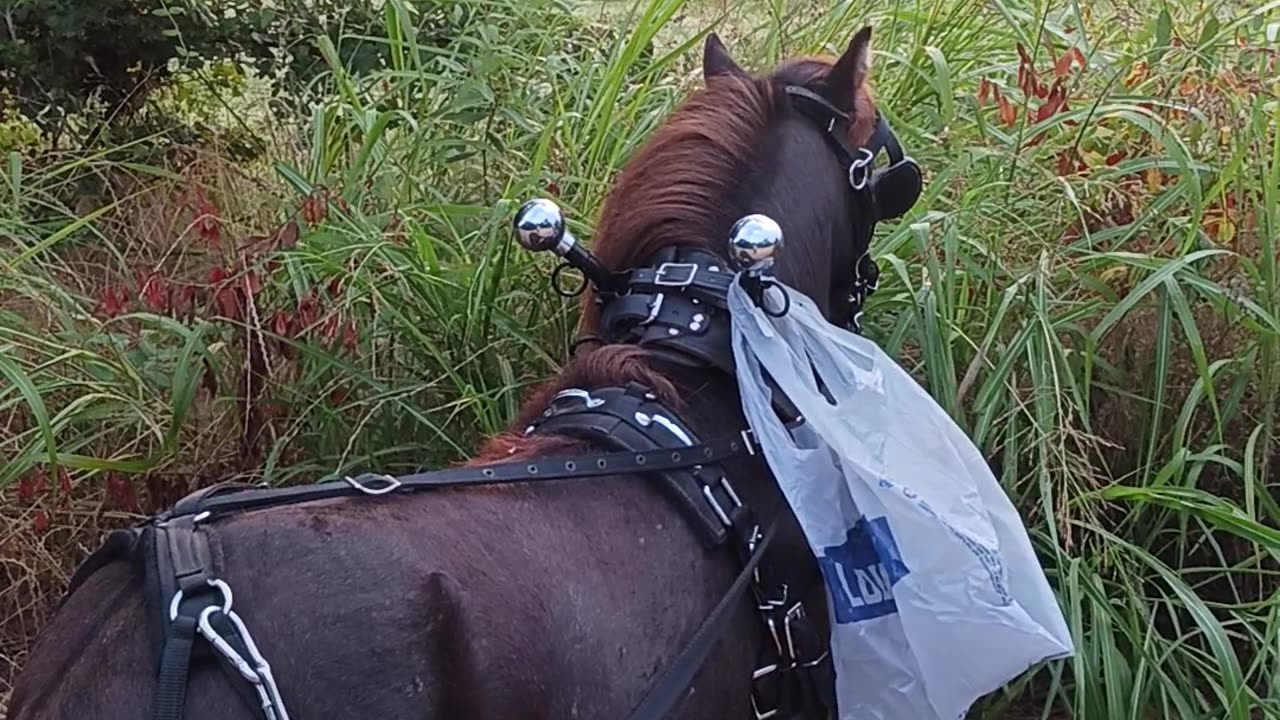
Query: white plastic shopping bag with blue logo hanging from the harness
728 282 1074 720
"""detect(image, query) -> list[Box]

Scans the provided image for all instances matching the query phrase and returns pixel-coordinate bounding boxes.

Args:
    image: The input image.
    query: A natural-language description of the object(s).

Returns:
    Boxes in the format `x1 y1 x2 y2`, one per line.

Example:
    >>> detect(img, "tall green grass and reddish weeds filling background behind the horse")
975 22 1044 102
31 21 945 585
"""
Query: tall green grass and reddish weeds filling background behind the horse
0 0 1280 720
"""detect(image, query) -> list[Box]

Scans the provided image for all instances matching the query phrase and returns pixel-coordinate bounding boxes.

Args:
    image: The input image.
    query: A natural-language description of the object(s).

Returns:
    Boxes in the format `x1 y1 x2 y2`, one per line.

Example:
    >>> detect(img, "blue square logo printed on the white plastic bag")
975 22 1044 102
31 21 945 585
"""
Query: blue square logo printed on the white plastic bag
818 518 909 625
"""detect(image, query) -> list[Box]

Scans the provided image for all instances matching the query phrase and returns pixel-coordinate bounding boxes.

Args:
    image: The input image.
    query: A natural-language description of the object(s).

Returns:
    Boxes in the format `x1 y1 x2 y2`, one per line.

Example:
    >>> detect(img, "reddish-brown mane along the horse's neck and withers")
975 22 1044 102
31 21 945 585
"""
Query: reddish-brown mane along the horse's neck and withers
472 58 873 462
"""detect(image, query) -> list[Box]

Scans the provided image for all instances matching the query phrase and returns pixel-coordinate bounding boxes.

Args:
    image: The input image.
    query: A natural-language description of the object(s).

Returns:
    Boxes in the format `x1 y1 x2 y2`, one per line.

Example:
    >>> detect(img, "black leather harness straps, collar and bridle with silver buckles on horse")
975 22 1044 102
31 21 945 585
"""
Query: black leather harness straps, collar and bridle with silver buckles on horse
55 86 922 720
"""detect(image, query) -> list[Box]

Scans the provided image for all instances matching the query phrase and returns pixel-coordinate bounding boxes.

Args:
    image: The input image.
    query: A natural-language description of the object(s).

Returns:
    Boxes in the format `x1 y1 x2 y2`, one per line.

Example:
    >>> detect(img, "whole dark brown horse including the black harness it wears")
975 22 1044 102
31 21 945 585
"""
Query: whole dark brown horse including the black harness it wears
10 28 920 720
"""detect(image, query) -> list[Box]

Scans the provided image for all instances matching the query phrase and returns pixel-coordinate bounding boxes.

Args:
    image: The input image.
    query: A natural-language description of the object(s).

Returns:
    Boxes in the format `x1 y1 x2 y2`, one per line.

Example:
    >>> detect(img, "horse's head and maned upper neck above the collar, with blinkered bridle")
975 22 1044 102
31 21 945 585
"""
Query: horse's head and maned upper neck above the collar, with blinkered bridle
584 27 922 331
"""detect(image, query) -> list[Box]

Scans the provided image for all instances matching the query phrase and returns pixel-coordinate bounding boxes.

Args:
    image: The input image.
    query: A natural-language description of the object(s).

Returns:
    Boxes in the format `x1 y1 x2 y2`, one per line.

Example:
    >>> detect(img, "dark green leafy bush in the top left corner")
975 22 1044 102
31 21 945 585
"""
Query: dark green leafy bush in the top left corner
0 0 435 142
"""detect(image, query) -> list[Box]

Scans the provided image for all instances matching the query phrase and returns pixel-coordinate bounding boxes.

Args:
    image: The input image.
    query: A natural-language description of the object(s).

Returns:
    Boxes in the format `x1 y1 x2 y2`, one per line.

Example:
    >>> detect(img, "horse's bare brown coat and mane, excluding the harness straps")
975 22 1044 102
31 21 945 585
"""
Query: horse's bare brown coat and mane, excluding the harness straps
10 28 918 720
